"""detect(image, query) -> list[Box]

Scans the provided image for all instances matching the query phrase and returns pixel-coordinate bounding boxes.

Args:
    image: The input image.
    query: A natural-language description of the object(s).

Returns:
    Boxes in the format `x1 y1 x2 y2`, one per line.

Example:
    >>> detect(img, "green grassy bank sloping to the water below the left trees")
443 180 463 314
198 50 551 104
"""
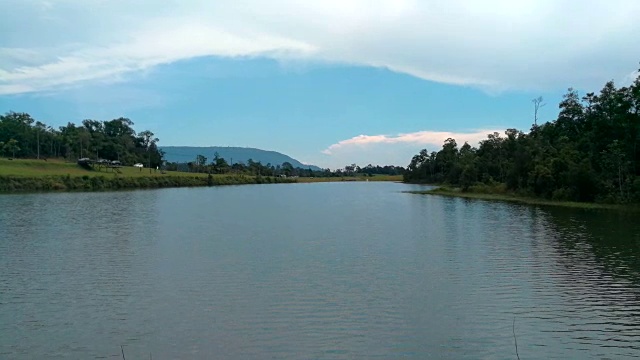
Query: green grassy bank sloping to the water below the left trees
0 159 295 193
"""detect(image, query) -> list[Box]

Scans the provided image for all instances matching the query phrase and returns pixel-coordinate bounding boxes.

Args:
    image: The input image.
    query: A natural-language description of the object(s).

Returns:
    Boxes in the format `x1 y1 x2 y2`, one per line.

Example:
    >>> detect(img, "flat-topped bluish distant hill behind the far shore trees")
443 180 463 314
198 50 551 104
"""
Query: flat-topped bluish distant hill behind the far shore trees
160 146 322 171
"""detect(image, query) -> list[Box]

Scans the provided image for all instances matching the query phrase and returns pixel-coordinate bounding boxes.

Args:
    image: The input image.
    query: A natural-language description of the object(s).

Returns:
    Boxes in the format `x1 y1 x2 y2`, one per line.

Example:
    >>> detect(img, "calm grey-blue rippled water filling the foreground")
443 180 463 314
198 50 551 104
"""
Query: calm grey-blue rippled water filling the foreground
0 182 640 359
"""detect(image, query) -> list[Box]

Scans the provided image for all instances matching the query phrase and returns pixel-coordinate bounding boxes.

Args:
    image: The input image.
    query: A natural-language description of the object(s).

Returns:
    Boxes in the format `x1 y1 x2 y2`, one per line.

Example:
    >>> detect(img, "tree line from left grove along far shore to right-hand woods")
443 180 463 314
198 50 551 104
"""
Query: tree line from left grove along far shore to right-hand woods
0 111 404 177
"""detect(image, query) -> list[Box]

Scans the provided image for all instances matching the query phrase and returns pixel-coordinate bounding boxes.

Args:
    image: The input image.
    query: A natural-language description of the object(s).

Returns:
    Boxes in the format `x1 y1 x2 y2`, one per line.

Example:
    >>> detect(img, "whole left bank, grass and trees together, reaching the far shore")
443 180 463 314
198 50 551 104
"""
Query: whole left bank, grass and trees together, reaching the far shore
0 112 404 192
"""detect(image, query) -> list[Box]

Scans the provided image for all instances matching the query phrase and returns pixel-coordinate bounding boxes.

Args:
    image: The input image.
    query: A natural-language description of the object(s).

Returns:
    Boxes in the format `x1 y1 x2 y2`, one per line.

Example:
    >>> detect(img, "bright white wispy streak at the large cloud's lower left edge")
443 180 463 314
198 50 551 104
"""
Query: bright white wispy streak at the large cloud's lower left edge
0 20 310 95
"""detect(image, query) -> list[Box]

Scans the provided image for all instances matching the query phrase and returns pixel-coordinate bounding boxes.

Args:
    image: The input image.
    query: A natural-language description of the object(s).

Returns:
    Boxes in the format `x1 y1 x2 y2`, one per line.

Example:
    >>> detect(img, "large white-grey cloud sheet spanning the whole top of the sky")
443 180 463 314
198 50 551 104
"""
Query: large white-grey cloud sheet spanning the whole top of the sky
0 0 640 94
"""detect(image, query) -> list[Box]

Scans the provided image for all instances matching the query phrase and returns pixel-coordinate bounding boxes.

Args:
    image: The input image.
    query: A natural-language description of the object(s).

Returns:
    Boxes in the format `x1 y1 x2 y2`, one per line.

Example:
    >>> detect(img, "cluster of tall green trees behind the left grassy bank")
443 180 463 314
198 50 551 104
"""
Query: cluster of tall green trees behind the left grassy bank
0 112 163 167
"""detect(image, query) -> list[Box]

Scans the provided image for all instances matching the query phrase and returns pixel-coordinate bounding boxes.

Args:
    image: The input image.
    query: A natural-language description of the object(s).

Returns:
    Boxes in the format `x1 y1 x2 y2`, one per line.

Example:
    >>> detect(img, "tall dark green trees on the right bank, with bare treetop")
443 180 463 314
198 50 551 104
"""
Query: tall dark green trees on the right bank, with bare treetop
404 67 640 203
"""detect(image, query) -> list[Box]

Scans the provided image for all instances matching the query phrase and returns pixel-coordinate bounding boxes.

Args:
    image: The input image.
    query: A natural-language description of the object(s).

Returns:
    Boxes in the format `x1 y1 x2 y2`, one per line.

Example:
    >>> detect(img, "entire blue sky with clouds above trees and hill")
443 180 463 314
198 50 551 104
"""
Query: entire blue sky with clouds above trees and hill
0 0 640 169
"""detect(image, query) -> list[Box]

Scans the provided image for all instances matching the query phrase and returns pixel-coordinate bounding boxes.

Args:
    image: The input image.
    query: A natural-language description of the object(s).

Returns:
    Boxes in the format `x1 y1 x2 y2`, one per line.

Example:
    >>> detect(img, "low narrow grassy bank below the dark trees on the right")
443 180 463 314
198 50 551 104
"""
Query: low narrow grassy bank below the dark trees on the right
409 186 640 211
